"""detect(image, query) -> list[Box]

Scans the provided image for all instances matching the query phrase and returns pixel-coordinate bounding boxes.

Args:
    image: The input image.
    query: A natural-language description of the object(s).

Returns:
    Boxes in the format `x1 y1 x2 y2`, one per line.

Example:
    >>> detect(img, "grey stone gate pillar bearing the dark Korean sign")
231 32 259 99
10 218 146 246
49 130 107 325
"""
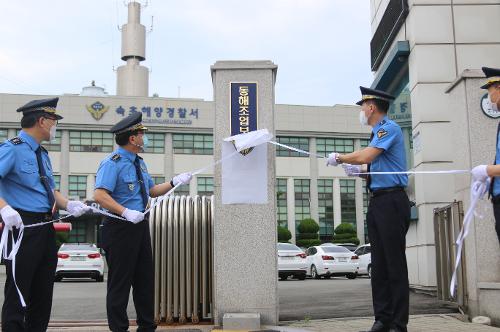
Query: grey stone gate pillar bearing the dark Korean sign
211 61 278 325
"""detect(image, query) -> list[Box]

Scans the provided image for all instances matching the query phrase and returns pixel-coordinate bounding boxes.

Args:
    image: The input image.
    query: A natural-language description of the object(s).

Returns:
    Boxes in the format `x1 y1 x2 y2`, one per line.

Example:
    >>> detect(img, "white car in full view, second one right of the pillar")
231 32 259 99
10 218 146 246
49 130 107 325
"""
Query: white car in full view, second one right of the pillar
306 245 358 279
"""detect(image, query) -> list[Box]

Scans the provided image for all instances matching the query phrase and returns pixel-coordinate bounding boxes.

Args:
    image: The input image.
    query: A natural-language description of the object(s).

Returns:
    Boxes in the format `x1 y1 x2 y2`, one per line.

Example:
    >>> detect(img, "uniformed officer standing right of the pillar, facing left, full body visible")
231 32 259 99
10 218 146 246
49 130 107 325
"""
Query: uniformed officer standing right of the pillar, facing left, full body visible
327 87 410 331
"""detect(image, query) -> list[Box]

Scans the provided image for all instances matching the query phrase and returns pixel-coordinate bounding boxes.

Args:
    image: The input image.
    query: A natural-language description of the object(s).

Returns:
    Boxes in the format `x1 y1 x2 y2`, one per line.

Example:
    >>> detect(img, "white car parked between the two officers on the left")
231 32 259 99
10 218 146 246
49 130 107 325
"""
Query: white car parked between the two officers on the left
55 243 104 282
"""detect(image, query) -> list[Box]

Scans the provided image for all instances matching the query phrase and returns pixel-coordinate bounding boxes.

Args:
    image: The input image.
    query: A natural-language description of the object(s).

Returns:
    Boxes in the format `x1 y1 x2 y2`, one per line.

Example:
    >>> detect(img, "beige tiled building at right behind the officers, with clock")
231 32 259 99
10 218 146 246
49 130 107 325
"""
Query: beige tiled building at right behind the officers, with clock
370 0 500 323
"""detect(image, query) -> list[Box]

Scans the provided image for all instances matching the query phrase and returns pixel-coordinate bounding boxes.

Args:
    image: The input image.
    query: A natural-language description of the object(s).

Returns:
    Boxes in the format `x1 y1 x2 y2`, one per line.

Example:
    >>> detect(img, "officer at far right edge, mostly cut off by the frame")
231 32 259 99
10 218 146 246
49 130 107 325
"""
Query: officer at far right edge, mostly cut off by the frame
472 67 500 242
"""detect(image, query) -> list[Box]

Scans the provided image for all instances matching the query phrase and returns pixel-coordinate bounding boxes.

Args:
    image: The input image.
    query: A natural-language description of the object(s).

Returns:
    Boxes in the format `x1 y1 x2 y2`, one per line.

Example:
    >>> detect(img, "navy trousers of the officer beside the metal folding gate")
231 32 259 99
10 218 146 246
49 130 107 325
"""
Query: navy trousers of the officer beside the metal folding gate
102 218 156 332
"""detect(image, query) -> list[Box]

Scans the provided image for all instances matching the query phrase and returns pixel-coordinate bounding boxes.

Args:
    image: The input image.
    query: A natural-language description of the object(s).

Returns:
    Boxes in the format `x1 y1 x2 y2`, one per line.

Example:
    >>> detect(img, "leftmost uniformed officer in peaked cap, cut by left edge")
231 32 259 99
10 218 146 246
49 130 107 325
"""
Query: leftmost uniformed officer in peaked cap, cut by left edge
0 98 88 331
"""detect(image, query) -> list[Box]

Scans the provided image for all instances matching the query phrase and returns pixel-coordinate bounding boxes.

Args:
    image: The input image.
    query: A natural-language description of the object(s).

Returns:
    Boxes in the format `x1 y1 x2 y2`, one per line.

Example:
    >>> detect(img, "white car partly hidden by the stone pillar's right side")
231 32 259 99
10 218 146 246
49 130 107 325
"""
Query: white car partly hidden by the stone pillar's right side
278 243 307 280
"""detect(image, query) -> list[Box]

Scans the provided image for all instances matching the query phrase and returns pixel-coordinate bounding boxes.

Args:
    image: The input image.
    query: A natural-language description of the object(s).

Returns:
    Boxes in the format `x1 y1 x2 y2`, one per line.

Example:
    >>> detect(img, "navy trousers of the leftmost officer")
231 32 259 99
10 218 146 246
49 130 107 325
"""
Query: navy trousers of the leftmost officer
2 210 57 332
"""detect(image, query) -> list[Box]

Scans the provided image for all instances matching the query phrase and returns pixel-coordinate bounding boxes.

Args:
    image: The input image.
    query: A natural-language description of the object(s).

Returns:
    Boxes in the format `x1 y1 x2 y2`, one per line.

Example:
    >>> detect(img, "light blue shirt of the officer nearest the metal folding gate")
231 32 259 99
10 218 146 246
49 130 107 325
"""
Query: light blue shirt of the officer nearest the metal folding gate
95 147 155 212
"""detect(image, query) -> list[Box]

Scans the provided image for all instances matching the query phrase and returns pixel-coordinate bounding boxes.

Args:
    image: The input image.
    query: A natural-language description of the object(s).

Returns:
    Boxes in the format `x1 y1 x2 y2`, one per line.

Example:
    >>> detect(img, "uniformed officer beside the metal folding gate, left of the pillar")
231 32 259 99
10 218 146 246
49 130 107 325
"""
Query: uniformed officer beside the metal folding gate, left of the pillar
94 113 191 331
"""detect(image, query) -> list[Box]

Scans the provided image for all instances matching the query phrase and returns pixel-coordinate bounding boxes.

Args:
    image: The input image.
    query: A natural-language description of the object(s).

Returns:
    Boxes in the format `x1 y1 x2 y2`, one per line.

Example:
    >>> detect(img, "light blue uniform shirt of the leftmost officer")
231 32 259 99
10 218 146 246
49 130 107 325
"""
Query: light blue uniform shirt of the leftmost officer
0 130 56 212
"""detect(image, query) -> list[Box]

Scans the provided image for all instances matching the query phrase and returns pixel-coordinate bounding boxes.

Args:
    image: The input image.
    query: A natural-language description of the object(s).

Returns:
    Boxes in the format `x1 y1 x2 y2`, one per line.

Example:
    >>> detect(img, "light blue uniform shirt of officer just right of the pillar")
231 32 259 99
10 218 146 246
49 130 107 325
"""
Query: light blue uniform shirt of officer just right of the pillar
369 116 408 190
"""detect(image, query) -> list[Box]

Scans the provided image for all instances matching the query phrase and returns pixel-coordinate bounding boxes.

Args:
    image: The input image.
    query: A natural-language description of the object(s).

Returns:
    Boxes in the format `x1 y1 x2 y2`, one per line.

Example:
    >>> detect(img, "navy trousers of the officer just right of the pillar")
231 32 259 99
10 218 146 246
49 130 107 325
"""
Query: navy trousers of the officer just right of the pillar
366 189 410 331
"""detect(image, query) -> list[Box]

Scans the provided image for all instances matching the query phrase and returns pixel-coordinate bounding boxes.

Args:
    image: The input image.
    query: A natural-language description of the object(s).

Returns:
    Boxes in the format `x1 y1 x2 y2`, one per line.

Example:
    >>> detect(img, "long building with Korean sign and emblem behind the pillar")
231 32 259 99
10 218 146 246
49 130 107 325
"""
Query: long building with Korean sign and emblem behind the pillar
0 92 369 243
